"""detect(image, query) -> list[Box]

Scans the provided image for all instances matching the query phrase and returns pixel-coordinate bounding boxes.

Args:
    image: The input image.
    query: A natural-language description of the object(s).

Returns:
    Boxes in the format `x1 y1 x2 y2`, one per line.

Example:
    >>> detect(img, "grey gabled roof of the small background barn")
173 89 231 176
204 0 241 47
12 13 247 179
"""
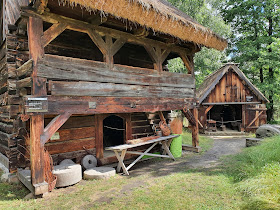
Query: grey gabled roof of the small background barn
196 63 269 104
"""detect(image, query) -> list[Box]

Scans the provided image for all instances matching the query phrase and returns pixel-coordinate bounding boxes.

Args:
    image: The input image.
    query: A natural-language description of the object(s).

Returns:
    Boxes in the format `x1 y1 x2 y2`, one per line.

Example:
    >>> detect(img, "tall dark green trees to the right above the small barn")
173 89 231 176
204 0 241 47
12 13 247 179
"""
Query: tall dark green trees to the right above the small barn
221 0 280 121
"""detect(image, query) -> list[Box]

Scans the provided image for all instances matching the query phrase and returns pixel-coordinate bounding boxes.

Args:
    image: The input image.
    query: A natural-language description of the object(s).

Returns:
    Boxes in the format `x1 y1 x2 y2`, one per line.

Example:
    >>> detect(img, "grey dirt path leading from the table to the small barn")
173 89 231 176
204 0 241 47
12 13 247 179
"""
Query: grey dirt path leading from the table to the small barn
130 137 246 176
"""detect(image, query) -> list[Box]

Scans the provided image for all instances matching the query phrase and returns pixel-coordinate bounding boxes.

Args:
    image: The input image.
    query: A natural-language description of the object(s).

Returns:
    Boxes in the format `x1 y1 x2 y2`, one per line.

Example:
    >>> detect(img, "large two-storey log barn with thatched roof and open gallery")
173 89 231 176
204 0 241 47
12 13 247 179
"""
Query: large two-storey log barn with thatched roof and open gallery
0 0 227 194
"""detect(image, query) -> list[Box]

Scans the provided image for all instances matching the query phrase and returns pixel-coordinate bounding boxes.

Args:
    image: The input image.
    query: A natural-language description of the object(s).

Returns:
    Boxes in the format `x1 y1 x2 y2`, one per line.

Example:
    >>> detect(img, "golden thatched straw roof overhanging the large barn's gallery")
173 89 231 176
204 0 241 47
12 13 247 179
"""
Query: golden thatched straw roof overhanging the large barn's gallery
59 0 227 50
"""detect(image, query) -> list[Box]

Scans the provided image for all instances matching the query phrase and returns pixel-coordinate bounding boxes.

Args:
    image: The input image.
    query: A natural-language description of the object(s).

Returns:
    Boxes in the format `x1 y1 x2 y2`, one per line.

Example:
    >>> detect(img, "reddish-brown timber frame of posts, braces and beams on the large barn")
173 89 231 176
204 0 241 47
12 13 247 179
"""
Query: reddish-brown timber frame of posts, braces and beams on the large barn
19 6 198 194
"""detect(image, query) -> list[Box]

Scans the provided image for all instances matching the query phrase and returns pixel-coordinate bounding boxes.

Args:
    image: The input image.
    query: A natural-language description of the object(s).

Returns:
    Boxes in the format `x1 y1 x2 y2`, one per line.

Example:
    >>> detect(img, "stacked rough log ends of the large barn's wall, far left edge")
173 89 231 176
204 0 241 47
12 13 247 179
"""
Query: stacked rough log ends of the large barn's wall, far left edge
0 34 28 172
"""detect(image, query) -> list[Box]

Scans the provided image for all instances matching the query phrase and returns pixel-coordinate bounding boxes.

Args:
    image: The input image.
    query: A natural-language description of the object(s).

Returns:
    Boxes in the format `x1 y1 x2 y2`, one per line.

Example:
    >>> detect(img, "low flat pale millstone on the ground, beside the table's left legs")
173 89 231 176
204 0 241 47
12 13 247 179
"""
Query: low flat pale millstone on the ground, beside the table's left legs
84 167 116 179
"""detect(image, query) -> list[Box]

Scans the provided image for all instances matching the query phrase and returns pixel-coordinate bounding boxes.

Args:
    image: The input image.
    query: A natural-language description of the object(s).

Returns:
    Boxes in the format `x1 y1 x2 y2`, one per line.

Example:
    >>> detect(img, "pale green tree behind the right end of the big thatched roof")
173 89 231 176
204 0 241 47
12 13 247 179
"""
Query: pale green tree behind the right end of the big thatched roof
168 0 231 85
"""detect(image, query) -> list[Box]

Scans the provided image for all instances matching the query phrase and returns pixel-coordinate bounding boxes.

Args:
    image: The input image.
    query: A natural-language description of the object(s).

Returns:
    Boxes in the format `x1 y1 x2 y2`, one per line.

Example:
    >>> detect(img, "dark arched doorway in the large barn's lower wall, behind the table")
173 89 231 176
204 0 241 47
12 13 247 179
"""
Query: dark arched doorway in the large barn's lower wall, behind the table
103 115 125 148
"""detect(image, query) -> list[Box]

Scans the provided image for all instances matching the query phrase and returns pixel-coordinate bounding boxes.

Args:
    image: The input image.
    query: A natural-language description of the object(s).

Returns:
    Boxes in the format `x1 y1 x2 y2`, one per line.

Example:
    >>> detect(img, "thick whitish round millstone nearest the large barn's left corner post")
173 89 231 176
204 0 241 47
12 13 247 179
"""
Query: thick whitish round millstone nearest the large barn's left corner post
53 164 82 187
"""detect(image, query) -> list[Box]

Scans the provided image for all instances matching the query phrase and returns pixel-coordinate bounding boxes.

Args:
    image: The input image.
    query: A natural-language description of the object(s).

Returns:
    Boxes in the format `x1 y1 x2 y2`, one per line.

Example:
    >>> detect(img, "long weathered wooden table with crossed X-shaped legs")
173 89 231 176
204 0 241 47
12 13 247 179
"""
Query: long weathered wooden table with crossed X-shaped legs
105 135 180 175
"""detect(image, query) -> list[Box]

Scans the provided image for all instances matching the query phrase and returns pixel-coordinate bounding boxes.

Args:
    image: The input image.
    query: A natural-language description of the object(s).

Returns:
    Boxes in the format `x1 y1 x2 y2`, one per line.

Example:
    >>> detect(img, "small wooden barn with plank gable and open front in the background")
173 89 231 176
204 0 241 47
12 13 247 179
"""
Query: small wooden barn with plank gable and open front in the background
196 64 268 132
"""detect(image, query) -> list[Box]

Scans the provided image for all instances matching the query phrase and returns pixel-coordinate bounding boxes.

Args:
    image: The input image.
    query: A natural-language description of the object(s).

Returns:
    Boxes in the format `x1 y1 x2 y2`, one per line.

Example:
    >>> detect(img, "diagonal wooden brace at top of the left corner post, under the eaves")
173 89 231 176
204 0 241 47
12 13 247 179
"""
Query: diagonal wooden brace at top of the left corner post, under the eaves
42 23 67 47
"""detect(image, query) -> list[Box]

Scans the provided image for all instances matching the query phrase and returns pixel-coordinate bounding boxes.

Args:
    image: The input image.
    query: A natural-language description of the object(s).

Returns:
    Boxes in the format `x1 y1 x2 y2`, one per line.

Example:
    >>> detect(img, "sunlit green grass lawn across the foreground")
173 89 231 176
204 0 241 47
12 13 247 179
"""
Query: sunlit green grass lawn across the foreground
0 133 280 209
